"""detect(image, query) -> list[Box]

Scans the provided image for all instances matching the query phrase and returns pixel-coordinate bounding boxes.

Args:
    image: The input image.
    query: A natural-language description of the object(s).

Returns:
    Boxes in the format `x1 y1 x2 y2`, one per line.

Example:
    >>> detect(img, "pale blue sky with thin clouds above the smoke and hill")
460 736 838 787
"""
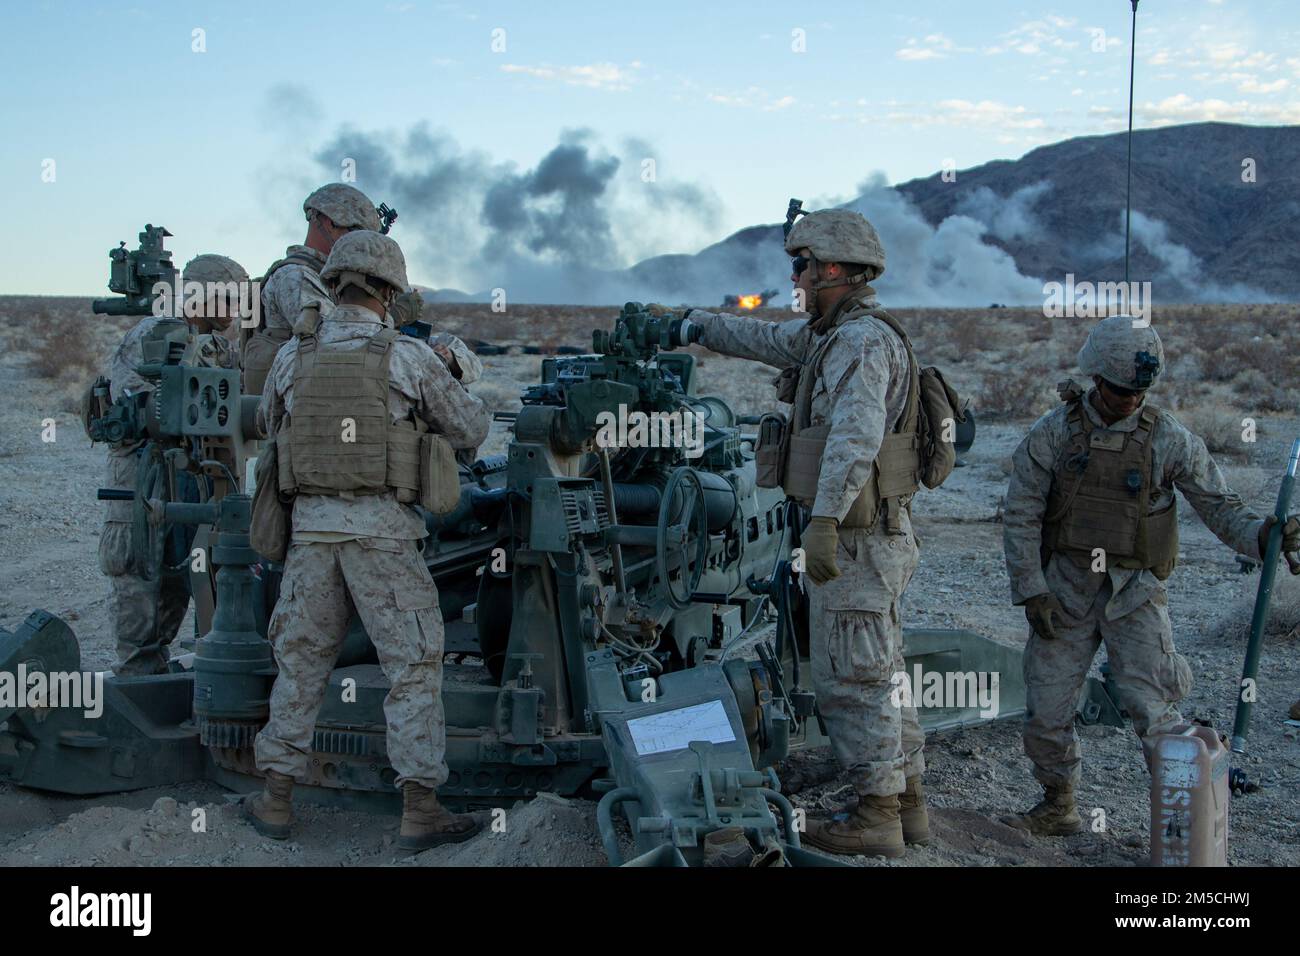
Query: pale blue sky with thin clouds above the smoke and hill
0 0 1300 294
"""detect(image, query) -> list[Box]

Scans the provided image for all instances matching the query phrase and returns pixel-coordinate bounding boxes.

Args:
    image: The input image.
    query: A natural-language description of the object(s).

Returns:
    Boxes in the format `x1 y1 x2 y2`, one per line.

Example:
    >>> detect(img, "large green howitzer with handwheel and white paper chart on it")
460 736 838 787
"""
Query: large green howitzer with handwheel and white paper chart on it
0 303 1045 865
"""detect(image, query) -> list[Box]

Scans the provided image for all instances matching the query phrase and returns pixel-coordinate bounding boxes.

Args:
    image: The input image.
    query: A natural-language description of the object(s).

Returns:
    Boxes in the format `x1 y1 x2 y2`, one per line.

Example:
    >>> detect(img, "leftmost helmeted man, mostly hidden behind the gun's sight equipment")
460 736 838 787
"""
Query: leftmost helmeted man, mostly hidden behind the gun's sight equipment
99 254 248 678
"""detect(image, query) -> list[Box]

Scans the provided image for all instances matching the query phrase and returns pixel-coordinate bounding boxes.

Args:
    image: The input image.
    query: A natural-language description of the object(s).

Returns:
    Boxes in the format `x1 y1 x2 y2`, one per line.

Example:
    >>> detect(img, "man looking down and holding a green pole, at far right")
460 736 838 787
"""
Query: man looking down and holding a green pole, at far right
1002 316 1300 834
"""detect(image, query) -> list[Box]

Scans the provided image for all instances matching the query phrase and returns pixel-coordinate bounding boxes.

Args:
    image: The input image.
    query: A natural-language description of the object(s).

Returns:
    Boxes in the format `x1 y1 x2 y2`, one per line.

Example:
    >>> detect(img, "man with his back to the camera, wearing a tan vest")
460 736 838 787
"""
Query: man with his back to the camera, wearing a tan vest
246 232 490 849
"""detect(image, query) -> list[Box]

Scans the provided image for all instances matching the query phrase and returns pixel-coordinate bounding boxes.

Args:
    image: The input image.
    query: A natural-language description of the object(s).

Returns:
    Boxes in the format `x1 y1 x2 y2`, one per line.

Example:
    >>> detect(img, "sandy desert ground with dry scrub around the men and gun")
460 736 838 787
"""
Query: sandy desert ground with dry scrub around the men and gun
0 297 1300 866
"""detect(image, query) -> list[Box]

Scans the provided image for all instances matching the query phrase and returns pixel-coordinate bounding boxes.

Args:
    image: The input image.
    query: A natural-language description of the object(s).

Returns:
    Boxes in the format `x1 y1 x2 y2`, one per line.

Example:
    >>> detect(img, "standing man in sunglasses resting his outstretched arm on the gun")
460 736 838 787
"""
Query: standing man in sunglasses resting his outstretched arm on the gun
685 209 930 856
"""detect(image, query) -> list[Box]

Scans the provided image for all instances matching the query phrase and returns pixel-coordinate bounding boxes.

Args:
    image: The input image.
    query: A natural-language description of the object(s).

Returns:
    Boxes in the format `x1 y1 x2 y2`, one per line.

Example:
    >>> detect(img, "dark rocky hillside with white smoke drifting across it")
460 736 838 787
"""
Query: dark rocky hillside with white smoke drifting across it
620 122 1300 306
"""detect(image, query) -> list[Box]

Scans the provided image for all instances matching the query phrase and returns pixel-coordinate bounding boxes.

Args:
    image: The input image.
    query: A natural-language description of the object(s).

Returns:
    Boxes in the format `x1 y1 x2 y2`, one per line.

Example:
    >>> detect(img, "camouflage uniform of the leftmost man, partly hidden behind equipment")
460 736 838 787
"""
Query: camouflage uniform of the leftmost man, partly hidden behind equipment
99 315 190 676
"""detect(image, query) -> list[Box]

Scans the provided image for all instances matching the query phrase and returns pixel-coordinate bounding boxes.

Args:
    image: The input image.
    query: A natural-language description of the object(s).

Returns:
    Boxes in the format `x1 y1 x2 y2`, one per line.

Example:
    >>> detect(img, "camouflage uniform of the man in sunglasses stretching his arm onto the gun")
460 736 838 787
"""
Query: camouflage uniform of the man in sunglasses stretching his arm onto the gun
690 294 926 796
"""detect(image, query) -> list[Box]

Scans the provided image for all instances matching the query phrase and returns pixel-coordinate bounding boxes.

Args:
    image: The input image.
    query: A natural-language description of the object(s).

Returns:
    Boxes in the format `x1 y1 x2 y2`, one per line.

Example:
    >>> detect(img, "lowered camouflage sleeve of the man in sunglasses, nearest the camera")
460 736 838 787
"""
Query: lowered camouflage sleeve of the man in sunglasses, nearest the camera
813 330 894 522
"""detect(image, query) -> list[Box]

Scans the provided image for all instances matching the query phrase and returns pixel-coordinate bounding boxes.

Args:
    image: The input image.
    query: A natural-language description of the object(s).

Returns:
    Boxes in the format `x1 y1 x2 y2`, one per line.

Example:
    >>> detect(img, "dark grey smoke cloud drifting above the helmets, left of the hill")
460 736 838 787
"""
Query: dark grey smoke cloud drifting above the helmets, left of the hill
315 125 719 303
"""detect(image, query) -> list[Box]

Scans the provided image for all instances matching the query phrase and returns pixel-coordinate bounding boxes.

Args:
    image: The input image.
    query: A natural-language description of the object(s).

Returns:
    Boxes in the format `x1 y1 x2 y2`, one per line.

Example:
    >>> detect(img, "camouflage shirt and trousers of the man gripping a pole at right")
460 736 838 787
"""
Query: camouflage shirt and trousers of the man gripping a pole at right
1004 389 1262 788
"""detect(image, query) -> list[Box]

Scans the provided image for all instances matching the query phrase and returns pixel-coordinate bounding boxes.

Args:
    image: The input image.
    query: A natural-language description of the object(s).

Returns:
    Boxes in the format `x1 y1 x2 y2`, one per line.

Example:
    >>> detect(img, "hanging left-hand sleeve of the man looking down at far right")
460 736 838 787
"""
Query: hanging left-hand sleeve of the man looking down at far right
1002 419 1057 605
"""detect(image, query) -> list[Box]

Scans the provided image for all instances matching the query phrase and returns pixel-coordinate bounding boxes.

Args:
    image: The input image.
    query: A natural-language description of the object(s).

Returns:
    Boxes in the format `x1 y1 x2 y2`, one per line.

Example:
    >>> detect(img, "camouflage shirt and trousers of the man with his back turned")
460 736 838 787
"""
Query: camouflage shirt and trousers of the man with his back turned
256 306 490 788
